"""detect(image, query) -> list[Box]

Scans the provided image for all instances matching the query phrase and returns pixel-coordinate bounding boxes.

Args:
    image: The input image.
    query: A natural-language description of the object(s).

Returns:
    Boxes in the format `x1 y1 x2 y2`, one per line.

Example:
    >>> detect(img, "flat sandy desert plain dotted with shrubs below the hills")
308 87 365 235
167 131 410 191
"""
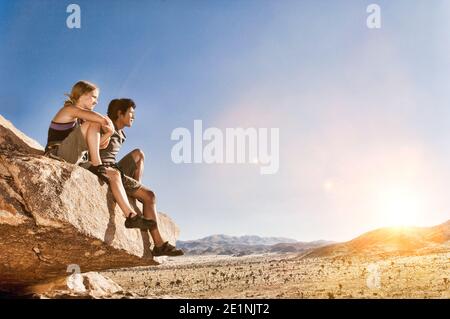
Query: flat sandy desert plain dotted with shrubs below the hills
101 252 450 298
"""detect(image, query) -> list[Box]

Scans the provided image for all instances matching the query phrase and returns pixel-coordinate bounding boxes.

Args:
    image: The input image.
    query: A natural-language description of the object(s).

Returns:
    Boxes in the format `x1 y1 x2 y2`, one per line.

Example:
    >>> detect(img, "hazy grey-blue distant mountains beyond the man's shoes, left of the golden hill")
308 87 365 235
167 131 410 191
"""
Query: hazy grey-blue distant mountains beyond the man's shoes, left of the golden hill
177 235 332 256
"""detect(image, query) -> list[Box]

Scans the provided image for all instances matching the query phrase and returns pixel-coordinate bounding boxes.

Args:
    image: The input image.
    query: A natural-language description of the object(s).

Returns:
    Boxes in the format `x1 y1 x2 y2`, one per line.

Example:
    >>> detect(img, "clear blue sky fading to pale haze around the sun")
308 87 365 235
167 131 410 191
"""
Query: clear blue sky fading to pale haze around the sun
0 0 450 240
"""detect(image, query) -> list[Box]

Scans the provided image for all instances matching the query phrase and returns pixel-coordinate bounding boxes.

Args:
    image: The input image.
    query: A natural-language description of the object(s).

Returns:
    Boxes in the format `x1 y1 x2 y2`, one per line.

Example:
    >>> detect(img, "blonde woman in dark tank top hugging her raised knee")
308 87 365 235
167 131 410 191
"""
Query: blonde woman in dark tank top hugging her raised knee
45 81 152 230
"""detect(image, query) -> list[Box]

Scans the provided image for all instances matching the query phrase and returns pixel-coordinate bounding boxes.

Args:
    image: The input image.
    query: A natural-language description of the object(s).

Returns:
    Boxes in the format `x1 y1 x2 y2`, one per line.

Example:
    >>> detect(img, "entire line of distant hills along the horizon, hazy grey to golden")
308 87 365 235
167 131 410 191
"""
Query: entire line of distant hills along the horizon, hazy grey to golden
177 220 450 258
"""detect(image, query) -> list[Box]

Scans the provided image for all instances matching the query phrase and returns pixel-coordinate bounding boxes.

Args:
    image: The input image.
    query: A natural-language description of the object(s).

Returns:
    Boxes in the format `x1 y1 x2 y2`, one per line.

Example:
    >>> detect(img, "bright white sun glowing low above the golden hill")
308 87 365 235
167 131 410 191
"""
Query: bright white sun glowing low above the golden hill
377 187 424 227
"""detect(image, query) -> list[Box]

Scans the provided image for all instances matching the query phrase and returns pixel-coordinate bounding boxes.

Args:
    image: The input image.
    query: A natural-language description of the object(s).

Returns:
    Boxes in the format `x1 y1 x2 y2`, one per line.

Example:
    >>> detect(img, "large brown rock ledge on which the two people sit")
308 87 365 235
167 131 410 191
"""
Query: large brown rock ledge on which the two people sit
0 116 179 296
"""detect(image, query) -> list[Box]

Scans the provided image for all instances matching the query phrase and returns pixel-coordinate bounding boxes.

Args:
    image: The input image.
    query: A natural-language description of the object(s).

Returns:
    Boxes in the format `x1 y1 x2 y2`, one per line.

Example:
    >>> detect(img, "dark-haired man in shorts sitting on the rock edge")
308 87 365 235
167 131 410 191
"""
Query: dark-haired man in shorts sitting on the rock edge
100 99 183 256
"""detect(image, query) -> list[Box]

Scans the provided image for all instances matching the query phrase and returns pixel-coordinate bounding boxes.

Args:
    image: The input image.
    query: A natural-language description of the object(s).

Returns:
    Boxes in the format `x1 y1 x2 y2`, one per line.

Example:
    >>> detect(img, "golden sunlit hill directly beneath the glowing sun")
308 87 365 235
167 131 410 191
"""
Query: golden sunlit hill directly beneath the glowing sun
303 220 450 257
